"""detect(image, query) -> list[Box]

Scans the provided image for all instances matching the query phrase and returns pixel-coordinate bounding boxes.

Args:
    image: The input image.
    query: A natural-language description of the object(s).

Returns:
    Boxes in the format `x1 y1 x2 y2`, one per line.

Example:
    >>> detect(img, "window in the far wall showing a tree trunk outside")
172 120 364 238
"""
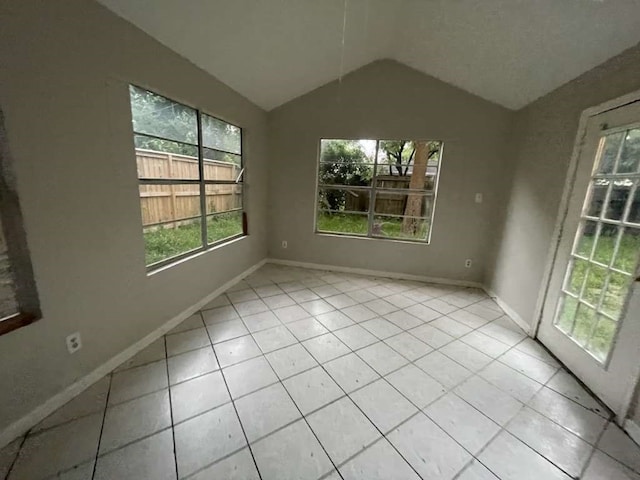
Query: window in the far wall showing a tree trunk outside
316 139 443 243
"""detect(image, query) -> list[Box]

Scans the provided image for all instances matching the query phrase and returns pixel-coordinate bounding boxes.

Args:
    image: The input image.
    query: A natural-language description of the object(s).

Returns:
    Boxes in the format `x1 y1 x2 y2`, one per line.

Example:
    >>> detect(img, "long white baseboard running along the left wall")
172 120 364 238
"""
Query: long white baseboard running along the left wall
0 259 267 448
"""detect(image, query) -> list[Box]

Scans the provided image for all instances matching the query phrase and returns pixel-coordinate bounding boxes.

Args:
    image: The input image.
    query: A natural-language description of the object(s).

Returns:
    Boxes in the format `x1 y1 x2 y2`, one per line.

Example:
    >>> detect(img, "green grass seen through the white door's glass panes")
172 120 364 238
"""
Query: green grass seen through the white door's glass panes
557 233 640 361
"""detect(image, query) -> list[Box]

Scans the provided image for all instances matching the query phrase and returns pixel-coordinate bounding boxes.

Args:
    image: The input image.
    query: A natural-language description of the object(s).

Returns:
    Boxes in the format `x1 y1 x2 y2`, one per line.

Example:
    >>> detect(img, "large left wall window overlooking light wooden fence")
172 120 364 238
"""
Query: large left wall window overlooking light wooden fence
129 86 246 270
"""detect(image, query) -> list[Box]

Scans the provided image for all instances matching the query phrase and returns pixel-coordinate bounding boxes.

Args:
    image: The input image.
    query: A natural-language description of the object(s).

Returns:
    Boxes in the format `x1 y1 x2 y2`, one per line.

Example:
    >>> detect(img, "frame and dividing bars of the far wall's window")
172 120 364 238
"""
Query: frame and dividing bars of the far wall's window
313 138 445 245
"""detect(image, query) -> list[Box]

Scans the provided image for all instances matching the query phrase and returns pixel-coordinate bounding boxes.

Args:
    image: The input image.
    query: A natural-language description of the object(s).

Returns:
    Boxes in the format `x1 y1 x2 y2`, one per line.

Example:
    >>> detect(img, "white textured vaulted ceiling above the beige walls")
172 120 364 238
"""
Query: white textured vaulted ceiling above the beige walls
99 0 640 110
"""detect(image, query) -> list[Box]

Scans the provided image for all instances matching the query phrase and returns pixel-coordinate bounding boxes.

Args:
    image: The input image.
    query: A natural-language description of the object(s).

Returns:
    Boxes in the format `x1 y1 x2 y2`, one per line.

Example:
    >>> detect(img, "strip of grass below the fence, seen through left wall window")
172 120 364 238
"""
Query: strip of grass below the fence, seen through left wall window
144 213 242 265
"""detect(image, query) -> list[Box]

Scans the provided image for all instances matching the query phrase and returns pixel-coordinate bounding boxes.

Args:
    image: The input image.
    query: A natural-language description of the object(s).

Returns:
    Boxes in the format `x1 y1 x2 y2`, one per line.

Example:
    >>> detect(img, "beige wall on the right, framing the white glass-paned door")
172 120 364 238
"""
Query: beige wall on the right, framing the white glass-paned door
488 46 640 324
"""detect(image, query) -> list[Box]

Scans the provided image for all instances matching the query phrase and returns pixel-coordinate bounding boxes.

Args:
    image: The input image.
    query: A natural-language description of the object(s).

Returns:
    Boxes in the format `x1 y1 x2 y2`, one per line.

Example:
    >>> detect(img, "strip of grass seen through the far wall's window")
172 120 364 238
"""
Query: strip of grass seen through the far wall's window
317 212 429 240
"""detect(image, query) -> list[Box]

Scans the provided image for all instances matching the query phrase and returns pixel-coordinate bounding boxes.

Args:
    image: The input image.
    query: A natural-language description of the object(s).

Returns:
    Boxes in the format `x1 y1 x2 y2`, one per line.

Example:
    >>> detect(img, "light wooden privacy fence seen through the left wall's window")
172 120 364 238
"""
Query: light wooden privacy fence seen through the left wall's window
136 149 242 227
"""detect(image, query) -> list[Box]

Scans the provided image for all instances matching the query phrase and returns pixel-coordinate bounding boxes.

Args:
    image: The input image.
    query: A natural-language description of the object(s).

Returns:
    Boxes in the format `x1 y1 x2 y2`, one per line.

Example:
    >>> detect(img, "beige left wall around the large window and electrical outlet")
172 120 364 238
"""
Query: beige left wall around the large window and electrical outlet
0 0 267 431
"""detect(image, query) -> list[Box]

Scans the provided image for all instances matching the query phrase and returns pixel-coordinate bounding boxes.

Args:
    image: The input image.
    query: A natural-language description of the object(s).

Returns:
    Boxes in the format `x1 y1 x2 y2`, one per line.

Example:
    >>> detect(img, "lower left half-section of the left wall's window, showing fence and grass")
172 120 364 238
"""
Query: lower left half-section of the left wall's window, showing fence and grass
139 184 202 265
